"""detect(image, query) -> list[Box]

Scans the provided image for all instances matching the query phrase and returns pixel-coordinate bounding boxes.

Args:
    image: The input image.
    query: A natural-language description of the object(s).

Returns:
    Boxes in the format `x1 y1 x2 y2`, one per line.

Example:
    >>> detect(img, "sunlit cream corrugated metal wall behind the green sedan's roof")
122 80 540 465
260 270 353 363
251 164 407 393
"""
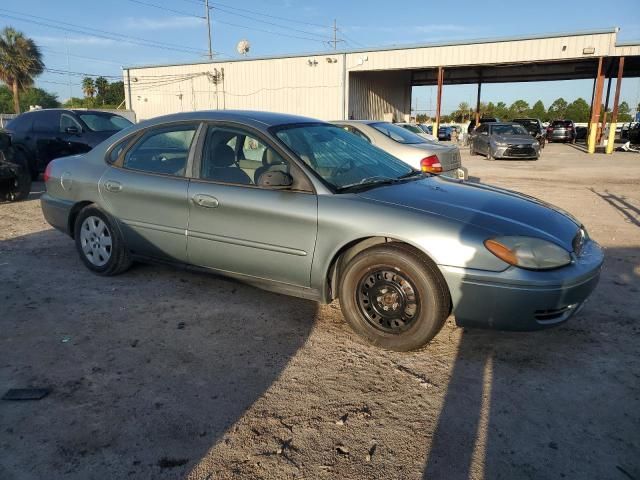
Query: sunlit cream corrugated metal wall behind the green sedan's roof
129 55 344 120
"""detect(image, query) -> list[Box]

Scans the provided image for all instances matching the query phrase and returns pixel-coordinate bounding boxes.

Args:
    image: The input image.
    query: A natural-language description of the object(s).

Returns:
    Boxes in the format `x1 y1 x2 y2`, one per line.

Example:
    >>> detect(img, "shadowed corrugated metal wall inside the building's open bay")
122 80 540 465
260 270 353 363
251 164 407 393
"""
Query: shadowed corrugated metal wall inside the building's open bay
348 71 411 122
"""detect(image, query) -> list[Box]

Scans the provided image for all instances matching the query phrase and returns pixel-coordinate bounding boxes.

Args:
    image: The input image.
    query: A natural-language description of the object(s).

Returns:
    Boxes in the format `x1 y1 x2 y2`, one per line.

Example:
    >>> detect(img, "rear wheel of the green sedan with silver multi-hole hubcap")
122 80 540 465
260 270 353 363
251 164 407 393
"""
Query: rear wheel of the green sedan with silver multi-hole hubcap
74 205 132 276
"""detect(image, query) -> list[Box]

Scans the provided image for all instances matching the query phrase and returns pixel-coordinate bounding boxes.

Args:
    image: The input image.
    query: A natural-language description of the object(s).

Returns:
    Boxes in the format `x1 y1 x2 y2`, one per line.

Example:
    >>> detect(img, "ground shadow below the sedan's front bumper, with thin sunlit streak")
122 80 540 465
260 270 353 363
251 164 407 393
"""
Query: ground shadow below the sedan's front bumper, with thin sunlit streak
423 248 640 480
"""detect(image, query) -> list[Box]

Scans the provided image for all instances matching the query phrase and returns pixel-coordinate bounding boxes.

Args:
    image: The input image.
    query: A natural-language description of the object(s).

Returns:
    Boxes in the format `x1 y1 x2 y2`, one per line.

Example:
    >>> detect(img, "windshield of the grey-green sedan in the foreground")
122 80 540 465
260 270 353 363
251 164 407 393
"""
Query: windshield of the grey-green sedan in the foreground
275 124 420 190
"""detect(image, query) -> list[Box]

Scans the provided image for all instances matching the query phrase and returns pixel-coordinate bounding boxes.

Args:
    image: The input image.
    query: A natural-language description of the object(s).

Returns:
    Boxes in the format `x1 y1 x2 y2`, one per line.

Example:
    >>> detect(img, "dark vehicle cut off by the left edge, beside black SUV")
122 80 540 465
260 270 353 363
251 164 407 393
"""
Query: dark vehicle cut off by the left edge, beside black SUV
0 131 31 202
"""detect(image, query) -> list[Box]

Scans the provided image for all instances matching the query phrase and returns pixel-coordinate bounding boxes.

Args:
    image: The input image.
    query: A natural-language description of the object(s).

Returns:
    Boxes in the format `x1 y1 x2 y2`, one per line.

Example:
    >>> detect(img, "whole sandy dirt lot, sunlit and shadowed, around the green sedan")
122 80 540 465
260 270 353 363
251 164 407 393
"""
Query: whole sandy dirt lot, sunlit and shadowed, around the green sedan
0 144 640 480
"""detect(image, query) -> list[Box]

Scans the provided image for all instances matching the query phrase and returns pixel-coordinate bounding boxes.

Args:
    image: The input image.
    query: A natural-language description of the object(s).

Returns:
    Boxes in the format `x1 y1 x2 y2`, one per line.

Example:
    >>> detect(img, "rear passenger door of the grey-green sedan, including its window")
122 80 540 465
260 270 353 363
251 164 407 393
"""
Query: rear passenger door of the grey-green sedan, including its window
99 122 200 262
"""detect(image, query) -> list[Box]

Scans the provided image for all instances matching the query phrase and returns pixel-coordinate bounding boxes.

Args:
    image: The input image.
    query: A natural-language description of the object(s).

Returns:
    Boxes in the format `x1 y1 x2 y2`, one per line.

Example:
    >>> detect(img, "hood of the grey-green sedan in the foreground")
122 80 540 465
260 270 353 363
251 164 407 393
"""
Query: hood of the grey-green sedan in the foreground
358 176 580 251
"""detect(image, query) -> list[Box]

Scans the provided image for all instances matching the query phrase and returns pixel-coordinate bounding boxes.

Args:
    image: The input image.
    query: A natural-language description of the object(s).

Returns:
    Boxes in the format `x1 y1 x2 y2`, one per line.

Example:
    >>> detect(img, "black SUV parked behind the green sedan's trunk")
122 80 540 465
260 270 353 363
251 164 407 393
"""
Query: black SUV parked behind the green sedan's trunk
6 109 133 180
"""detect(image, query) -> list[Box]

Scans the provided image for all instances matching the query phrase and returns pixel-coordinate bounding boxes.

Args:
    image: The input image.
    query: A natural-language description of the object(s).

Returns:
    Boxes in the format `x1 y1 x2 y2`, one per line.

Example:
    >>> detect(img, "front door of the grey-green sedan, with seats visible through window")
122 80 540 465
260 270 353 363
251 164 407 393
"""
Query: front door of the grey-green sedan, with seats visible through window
187 124 318 287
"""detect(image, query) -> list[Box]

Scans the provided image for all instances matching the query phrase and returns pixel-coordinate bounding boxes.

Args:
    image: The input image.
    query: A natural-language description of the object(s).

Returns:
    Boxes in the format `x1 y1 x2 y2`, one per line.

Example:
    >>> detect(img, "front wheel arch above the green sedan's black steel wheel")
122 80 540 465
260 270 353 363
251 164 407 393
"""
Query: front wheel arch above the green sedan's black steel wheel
324 236 446 303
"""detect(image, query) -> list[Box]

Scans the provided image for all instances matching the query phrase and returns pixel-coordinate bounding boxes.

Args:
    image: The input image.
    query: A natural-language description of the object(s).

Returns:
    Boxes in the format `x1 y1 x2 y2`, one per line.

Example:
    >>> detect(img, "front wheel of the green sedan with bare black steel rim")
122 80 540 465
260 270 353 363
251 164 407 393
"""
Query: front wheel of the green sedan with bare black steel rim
338 244 451 352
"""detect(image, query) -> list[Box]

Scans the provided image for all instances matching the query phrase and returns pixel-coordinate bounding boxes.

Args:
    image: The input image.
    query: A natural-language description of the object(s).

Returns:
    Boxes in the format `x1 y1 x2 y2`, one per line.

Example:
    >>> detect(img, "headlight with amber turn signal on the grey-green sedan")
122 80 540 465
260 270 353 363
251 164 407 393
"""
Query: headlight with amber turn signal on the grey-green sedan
484 237 571 270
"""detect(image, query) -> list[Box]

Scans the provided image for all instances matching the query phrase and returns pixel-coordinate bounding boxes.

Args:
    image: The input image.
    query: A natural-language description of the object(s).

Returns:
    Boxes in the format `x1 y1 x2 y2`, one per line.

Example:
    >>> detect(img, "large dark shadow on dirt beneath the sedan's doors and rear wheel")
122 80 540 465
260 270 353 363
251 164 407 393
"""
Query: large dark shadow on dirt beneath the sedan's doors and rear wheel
0 230 317 479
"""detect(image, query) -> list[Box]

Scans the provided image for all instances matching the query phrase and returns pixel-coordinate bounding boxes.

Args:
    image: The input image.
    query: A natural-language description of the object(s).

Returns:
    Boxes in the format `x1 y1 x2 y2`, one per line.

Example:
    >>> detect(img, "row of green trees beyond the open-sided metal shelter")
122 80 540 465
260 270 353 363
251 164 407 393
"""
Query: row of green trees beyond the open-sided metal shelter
416 97 640 123
